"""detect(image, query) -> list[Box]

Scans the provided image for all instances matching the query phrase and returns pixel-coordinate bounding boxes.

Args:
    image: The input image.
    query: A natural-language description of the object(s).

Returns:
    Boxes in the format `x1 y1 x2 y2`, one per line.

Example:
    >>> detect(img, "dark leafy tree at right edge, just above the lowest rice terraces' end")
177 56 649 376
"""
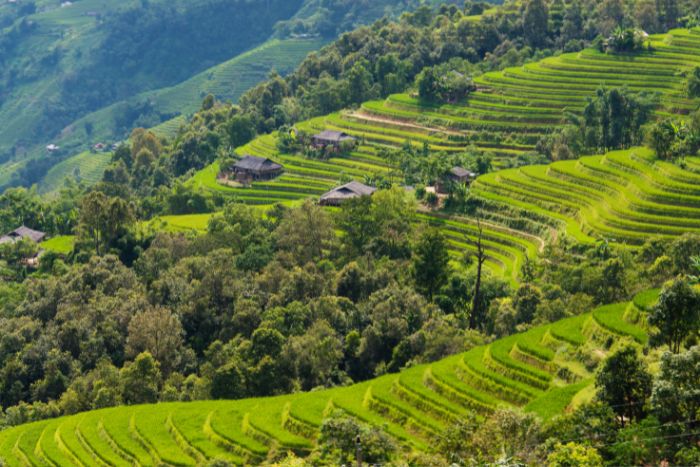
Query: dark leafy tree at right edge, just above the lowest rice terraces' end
648 278 700 353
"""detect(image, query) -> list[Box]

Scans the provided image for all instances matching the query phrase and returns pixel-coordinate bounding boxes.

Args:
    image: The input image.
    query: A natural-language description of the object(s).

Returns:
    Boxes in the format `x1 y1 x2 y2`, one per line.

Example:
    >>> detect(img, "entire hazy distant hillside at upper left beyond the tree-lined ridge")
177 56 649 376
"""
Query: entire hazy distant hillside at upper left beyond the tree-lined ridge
0 0 470 192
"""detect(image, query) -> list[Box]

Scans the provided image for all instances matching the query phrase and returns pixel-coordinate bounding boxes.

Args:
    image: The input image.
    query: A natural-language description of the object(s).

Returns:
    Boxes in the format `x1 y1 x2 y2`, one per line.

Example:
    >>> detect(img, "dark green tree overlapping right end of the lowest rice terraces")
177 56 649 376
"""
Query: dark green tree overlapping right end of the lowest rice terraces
595 346 651 426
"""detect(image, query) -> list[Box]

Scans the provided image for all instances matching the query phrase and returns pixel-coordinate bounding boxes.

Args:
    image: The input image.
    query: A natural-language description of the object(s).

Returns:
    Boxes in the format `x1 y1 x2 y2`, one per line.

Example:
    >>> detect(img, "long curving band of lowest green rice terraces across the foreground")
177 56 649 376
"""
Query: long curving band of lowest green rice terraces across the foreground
0 297 649 466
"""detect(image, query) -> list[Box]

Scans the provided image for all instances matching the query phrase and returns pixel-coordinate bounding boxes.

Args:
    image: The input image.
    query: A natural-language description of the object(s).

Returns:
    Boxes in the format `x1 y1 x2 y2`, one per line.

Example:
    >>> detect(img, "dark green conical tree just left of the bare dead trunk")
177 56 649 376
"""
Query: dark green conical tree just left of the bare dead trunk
413 228 450 301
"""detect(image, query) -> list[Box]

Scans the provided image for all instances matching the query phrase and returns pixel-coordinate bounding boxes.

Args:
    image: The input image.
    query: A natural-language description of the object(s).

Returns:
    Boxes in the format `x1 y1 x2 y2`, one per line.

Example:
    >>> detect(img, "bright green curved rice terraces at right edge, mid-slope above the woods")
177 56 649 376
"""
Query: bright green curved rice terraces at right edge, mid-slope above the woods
472 148 700 245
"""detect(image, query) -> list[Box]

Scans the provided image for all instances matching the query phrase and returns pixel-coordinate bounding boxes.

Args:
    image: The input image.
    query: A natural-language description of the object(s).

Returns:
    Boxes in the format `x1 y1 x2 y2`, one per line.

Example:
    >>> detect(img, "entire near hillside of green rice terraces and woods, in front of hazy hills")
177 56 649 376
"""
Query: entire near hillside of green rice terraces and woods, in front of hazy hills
0 0 700 466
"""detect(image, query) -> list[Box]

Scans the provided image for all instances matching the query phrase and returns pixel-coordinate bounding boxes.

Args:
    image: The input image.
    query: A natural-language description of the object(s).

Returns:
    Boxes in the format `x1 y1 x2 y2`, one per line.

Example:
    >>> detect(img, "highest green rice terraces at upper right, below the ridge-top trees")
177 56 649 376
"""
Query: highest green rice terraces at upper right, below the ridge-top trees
352 30 700 161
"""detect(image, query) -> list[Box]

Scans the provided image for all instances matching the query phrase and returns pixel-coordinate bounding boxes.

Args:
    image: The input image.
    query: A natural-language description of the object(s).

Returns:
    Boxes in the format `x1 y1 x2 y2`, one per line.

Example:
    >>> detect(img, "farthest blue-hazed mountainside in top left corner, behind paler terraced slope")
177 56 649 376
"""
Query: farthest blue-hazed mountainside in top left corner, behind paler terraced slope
0 0 302 159
